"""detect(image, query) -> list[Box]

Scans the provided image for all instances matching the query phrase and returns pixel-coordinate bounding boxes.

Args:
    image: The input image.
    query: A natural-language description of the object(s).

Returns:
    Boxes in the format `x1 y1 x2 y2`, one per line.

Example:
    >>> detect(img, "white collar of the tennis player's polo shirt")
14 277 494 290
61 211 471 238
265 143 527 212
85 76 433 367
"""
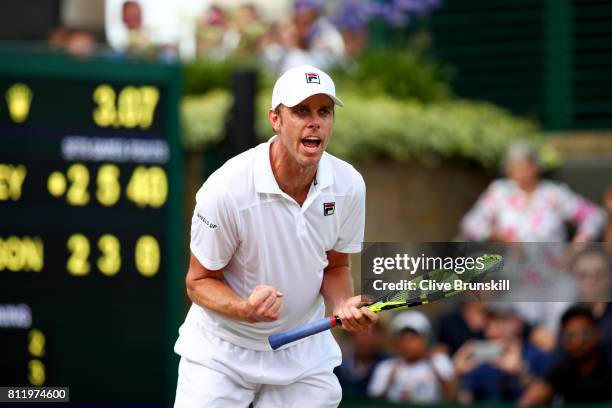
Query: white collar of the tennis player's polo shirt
255 136 333 194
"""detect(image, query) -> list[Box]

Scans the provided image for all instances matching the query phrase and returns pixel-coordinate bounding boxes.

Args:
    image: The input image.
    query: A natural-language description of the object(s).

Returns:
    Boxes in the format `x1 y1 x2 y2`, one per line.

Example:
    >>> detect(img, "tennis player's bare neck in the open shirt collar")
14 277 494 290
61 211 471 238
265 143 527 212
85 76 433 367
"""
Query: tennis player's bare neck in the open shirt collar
270 141 317 206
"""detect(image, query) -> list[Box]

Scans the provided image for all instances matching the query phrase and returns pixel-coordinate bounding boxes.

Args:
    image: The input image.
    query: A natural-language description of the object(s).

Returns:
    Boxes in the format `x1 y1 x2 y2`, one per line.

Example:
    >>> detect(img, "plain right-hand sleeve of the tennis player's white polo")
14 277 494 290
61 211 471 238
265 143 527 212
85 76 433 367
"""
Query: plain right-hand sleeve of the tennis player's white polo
334 174 366 254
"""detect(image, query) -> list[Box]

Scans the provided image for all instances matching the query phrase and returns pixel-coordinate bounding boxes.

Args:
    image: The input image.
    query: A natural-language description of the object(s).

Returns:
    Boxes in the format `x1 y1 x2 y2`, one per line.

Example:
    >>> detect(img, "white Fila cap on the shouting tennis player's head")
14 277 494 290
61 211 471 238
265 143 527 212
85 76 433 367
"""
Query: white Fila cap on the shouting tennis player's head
272 65 344 109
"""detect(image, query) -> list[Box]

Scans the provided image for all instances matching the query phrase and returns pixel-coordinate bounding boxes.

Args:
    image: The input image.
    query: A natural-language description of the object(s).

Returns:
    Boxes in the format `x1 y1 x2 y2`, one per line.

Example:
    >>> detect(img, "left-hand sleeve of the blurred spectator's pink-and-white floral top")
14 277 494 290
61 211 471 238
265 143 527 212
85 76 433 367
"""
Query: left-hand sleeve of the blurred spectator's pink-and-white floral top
461 182 501 241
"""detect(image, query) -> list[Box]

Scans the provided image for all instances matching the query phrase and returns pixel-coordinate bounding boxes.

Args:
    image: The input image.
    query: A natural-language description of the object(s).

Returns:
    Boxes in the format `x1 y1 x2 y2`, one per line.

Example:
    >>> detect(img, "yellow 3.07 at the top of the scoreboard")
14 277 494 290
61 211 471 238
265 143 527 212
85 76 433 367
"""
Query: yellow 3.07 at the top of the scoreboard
93 84 159 129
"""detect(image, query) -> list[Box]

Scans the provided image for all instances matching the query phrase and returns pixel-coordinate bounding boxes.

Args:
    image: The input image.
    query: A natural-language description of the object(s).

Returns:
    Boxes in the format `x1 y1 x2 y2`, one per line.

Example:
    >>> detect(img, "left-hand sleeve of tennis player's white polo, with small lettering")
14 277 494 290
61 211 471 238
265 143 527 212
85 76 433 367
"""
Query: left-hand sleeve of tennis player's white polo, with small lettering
189 180 239 270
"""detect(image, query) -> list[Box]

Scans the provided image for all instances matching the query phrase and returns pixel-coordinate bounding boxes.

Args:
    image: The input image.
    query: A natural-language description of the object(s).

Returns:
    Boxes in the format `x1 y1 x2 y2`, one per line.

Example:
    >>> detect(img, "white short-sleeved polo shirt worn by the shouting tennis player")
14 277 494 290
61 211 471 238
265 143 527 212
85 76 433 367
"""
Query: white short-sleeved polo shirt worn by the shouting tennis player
176 137 365 354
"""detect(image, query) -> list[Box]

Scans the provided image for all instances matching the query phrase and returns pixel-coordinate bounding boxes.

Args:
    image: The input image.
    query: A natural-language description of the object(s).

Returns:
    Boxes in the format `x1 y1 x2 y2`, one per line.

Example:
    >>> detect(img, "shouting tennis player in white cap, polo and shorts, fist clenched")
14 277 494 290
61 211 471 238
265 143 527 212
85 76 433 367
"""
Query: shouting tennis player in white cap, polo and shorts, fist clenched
175 66 377 407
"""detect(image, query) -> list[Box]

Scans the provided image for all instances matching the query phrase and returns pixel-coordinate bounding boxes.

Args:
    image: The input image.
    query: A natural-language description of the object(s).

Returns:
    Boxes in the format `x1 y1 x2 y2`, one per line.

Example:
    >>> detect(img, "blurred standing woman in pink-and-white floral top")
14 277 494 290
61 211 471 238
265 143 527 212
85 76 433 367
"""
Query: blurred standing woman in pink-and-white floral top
461 143 605 242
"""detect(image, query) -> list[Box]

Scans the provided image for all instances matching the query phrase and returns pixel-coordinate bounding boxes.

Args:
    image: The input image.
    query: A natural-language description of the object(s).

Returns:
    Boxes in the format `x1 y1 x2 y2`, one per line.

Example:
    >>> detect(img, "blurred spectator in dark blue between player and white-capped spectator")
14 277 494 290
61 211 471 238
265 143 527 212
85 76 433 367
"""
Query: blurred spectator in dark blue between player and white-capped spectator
334 324 387 396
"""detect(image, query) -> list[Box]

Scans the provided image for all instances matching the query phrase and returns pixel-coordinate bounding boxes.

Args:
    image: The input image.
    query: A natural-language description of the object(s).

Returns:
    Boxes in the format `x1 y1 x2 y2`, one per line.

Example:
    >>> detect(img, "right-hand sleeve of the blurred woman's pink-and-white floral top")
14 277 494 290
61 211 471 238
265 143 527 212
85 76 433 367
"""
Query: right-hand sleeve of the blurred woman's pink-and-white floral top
558 184 606 241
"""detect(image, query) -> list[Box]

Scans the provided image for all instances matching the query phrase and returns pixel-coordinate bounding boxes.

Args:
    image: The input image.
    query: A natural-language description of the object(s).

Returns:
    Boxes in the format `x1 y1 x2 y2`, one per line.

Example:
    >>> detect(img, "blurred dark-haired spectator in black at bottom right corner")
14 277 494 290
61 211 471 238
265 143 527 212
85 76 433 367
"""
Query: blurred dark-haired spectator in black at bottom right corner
519 306 612 406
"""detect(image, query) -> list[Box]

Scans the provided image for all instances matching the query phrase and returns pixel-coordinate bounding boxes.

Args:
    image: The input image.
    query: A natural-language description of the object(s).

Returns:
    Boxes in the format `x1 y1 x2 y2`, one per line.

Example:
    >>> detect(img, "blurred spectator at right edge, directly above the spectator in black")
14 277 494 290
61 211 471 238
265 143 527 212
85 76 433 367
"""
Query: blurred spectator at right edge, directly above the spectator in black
573 247 612 345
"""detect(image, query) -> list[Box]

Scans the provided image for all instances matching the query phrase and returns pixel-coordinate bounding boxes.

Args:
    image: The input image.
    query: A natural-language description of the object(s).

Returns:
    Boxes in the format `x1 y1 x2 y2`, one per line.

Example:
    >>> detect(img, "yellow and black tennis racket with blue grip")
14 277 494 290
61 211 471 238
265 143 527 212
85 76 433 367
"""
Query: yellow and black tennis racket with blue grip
268 255 503 350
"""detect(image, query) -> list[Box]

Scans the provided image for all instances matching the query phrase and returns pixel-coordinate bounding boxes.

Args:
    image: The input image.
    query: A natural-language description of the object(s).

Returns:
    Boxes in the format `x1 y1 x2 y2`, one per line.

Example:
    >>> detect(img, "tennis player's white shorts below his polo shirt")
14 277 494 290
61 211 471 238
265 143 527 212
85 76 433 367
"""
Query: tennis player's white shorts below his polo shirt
174 332 342 408
